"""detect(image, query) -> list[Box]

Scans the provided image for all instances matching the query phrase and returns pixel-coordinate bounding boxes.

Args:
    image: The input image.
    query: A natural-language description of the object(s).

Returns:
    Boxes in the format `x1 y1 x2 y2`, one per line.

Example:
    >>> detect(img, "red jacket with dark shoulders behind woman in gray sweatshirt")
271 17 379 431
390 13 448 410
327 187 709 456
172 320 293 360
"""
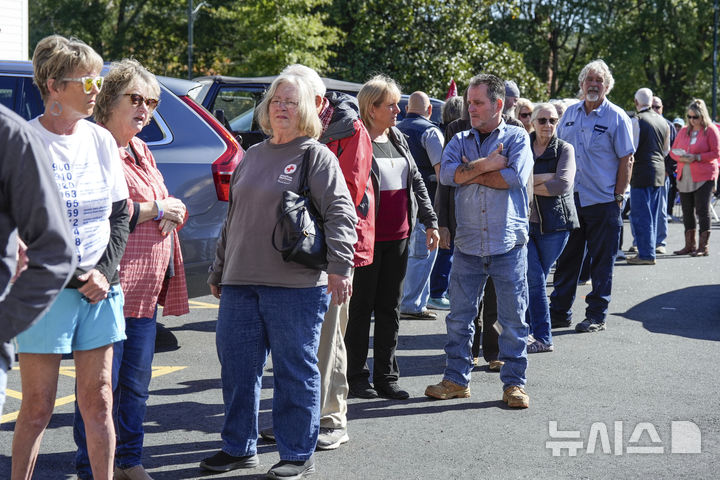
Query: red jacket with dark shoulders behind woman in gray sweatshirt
320 92 375 267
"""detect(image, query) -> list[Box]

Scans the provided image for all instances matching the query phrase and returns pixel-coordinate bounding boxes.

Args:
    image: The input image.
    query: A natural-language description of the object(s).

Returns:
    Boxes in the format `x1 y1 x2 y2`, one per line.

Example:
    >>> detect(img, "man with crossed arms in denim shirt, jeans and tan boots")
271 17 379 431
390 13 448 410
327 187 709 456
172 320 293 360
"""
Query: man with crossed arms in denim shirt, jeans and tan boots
425 75 533 408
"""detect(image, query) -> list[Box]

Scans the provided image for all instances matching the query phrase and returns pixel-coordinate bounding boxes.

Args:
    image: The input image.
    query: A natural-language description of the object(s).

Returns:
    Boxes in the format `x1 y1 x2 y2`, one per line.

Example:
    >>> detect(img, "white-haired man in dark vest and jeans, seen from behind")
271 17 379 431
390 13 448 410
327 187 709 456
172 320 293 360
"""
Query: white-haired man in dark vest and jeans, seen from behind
627 88 670 265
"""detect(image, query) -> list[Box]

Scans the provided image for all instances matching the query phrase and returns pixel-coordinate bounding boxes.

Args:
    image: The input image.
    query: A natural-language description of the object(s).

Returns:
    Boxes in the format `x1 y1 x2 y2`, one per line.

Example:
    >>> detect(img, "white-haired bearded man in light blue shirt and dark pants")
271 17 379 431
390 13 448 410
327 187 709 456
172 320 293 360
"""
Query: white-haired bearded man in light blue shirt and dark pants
550 60 635 332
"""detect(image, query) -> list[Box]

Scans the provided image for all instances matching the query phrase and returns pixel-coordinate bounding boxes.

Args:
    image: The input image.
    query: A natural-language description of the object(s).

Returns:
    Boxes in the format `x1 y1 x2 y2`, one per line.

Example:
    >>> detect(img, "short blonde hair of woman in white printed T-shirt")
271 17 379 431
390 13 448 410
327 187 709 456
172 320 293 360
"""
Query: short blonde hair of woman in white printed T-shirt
32 35 103 102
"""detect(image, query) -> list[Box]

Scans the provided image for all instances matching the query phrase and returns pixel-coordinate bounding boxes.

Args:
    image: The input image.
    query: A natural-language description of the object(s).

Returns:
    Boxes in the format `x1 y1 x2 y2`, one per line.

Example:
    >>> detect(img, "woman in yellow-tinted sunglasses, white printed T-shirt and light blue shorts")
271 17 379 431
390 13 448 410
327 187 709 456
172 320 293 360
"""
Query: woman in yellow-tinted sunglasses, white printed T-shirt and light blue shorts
11 35 129 480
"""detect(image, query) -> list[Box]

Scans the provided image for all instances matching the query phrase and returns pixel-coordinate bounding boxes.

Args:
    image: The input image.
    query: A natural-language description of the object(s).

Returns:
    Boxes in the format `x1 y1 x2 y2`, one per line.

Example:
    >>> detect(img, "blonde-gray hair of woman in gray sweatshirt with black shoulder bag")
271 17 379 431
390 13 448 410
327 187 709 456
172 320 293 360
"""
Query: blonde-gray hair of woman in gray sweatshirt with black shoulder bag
257 74 322 139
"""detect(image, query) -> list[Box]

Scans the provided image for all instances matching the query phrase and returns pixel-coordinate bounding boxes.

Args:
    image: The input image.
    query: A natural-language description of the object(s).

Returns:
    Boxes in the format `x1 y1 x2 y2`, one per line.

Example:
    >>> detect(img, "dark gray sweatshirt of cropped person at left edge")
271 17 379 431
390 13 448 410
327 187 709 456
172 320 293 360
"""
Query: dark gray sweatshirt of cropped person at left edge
0 105 75 355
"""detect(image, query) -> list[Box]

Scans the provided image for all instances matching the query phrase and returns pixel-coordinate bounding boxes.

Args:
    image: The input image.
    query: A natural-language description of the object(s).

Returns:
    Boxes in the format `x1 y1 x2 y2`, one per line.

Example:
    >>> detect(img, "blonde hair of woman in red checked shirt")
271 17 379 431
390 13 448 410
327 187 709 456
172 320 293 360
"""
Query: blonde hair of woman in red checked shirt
95 58 160 125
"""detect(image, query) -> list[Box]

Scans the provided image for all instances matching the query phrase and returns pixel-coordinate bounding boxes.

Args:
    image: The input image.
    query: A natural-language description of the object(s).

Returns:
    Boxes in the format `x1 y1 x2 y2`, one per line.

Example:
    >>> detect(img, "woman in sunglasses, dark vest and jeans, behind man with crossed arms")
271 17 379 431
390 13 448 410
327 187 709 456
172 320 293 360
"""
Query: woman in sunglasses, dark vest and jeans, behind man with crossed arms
527 103 580 353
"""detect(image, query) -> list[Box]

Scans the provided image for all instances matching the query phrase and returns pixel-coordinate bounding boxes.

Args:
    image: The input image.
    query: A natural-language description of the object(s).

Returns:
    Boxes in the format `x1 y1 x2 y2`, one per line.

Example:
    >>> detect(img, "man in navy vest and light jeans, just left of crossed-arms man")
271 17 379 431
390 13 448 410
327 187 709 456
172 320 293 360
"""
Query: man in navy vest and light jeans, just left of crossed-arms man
397 91 444 320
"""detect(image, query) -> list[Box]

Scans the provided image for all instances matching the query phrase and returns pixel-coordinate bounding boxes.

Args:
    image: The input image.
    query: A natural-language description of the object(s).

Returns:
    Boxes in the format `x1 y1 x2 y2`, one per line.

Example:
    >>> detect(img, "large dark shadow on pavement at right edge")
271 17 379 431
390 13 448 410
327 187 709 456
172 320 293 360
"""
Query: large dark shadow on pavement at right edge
615 285 720 341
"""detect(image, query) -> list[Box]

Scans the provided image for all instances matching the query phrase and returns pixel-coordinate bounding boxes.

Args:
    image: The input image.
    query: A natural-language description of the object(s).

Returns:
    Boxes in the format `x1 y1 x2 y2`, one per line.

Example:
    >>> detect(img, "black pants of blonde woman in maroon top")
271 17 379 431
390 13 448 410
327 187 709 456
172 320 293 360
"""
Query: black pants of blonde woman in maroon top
345 239 408 385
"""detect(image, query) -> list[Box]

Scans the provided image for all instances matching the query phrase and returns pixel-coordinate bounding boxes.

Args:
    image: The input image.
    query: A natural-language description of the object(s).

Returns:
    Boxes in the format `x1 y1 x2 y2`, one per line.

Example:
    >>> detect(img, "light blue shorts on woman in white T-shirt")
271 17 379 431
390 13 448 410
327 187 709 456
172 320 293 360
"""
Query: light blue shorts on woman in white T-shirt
17 285 126 353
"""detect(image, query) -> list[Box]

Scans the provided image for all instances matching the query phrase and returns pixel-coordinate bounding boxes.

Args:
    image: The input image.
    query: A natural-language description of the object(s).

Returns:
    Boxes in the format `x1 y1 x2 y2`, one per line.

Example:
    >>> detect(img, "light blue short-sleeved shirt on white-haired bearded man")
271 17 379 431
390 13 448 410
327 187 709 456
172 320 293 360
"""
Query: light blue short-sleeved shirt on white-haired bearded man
557 98 635 207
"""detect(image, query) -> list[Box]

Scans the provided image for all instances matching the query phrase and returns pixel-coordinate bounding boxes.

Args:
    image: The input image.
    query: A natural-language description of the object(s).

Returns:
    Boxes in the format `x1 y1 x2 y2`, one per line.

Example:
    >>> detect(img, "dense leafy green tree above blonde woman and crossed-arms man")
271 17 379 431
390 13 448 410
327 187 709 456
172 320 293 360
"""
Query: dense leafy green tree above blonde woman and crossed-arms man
330 0 542 98
